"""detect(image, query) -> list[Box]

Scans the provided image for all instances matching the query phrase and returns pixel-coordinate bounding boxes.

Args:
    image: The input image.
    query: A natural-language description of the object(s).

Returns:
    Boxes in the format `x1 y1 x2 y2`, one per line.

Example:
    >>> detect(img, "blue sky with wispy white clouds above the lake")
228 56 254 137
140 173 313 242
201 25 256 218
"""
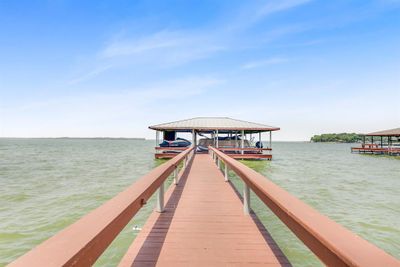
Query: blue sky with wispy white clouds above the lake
0 0 400 141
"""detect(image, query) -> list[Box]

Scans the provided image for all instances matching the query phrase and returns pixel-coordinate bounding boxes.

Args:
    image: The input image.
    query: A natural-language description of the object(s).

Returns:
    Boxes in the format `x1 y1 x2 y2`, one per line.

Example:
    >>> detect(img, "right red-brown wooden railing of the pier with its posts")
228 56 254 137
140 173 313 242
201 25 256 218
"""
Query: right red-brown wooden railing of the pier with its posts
209 147 400 266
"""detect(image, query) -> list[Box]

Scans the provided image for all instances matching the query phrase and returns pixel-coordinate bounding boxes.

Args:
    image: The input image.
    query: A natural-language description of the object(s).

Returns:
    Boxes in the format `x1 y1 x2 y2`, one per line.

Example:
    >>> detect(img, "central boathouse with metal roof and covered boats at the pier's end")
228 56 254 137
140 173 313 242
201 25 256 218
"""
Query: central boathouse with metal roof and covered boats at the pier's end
149 117 280 160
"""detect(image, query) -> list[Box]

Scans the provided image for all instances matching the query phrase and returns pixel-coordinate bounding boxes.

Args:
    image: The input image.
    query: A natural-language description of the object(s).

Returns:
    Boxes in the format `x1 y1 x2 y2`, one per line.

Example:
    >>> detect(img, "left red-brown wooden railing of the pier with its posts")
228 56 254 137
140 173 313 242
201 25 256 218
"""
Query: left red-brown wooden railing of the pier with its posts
9 147 194 267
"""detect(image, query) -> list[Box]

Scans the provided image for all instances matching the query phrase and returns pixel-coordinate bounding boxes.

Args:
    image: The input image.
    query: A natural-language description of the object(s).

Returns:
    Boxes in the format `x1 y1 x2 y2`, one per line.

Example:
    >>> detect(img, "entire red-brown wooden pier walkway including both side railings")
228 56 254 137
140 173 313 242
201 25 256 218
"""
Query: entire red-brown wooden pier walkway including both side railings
9 147 400 267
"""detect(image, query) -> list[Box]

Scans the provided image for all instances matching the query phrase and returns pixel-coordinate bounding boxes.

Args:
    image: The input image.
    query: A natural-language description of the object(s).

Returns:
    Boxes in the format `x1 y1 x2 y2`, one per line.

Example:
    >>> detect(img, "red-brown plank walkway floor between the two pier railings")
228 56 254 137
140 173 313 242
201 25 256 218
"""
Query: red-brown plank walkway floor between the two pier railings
120 154 290 266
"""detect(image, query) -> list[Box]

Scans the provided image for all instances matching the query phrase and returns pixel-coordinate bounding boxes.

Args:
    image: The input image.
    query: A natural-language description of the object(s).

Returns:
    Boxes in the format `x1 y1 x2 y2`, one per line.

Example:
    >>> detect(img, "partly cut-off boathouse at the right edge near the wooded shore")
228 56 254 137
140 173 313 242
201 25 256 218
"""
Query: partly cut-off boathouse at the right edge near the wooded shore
351 128 400 156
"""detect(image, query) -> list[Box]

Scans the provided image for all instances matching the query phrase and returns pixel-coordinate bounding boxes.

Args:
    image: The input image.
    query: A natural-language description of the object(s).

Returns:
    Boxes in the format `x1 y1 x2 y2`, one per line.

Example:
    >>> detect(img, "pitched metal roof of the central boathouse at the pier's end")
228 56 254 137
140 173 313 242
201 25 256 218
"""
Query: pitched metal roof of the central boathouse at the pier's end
149 117 280 131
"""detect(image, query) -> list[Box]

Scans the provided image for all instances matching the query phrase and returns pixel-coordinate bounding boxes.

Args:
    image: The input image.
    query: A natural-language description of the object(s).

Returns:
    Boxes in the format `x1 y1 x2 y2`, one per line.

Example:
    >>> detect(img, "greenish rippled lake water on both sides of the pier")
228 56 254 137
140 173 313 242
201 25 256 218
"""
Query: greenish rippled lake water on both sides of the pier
0 139 400 266
